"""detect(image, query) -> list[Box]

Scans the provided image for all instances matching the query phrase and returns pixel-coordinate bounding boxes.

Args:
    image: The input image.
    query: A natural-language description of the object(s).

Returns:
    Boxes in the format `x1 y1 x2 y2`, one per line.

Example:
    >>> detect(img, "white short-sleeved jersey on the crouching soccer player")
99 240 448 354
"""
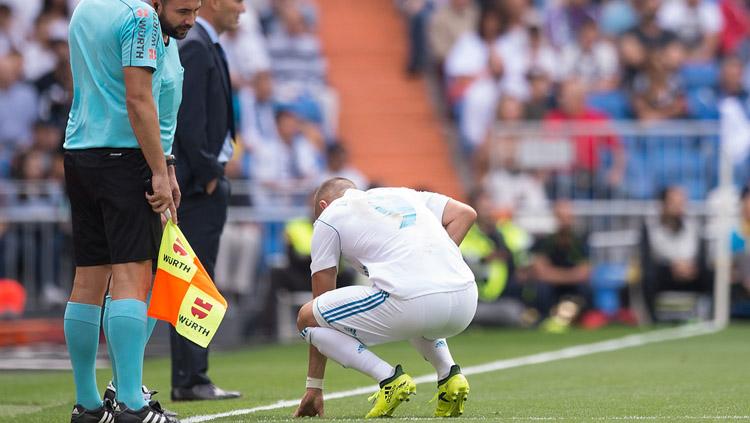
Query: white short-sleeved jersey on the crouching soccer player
310 188 474 299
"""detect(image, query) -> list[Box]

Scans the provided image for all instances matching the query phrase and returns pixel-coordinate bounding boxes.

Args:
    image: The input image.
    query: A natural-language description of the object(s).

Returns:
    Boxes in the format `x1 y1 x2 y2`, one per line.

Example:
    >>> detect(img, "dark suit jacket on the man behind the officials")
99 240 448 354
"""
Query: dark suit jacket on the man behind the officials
172 24 234 197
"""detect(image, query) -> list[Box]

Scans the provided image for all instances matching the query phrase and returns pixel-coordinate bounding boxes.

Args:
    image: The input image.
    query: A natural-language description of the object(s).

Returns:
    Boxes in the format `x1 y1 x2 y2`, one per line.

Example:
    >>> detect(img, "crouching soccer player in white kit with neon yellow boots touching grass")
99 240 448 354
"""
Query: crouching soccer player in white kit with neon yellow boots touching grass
294 178 477 418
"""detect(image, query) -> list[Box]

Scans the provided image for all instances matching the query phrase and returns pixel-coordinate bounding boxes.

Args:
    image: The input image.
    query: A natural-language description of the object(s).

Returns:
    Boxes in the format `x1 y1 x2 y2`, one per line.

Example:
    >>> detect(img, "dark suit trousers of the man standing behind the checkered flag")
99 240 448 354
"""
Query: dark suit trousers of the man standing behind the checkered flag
170 177 230 388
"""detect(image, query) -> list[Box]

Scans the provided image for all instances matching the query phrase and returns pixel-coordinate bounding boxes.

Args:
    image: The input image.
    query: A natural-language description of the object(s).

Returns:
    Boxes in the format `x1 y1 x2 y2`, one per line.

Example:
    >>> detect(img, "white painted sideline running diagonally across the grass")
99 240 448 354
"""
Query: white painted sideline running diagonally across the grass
182 323 724 423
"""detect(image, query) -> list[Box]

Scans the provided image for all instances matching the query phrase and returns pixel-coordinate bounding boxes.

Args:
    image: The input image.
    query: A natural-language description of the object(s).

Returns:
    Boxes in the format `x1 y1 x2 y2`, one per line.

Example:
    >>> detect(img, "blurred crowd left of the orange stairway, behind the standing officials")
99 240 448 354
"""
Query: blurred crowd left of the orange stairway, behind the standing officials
0 0 369 312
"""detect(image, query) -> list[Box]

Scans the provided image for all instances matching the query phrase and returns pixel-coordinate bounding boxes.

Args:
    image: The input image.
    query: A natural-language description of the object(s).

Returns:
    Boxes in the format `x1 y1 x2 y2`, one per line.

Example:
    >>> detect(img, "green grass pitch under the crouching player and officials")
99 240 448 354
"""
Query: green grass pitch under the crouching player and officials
0 324 750 423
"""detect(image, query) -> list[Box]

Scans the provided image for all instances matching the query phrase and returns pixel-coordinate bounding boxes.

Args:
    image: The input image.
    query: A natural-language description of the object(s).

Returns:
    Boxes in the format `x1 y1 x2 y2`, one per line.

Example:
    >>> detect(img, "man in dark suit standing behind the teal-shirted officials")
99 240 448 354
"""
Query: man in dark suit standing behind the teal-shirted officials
170 0 245 401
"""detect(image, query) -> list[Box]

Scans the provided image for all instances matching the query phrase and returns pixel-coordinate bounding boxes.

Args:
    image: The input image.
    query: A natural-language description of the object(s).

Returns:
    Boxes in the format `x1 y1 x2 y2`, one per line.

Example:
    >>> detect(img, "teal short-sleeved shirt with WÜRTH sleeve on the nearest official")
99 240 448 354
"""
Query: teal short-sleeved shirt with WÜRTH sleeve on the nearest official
64 0 166 150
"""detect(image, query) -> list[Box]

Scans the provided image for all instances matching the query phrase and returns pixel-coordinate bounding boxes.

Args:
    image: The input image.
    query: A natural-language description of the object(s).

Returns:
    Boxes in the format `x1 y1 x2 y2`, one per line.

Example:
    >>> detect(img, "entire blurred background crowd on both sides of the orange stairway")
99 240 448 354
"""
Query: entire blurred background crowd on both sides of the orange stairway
0 0 750 332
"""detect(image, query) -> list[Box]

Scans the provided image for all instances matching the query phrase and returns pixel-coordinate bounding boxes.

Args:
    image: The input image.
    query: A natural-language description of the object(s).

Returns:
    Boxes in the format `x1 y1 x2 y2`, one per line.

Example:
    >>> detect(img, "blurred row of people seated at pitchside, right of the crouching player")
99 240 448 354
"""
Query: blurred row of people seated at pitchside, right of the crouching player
461 186 750 333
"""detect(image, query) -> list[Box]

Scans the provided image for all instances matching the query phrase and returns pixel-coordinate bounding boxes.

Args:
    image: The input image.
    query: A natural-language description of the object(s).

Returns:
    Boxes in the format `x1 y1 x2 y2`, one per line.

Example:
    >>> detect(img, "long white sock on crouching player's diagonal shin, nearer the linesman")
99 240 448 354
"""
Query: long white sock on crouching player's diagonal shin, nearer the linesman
302 327 395 383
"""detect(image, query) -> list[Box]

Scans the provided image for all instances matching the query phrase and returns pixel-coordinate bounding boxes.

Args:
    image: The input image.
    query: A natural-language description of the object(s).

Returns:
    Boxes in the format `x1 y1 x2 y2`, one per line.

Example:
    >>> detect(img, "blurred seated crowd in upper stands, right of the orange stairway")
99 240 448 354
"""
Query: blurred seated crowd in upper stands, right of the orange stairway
397 0 750 208
